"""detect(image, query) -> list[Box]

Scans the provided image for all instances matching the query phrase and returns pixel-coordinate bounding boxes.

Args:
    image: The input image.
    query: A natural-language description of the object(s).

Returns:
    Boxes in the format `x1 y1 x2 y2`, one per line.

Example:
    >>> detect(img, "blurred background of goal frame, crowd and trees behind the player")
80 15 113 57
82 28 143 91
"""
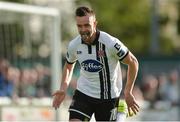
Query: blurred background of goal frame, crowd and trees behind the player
0 0 180 121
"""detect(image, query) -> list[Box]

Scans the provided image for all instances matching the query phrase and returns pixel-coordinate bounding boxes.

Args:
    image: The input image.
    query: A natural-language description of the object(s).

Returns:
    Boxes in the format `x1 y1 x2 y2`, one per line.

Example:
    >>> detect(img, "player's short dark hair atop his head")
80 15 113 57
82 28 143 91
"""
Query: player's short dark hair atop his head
76 6 95 17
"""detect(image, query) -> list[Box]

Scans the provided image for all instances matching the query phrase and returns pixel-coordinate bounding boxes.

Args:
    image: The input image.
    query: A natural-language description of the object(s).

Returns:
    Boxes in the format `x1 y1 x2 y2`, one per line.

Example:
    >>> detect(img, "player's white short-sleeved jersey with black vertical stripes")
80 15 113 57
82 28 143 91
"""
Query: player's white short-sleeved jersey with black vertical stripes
66 31 128 99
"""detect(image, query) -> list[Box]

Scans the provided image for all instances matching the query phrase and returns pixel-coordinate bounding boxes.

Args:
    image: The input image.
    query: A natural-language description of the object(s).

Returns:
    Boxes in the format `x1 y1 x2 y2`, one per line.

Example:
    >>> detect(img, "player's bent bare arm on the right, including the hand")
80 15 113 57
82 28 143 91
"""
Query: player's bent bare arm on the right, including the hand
122 51 139 114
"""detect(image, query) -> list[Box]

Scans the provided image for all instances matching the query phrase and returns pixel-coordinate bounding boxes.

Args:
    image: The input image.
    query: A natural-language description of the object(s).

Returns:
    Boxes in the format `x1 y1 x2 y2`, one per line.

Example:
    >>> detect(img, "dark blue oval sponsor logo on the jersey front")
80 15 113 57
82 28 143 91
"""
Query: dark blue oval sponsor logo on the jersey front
81 59 103 72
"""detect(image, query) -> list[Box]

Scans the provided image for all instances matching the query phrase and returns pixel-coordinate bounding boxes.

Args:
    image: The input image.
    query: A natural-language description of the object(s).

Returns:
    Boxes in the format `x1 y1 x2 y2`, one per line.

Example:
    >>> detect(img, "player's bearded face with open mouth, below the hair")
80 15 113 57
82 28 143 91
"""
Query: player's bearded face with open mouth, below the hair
76 15 97 44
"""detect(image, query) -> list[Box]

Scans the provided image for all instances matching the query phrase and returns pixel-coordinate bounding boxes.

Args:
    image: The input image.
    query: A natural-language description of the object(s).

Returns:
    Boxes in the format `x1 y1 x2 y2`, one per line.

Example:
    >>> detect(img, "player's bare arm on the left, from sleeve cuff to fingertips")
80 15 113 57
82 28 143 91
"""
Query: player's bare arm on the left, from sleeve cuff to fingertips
53 62 75 109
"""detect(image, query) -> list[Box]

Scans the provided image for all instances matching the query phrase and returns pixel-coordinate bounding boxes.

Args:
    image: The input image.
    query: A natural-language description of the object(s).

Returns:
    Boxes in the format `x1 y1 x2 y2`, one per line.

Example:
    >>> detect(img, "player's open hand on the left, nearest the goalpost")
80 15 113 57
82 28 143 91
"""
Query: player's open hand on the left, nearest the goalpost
52 90 65 109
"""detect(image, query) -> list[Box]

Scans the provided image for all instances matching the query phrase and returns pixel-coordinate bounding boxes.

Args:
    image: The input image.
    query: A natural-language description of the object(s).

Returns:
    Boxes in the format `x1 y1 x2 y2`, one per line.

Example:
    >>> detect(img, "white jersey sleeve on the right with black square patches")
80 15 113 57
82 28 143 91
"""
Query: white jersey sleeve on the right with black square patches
112 38 129 61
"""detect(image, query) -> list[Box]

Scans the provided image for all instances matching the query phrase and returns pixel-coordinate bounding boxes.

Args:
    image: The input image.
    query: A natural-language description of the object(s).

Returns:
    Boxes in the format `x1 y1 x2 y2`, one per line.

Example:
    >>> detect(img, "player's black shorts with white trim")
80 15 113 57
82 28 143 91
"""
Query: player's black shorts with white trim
69 90 119 121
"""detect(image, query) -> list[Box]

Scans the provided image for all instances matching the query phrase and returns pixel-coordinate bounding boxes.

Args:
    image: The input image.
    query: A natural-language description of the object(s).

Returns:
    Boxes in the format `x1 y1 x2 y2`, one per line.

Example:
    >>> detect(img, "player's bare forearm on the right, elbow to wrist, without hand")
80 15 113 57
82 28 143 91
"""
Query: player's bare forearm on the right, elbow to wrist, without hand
124 56 139 94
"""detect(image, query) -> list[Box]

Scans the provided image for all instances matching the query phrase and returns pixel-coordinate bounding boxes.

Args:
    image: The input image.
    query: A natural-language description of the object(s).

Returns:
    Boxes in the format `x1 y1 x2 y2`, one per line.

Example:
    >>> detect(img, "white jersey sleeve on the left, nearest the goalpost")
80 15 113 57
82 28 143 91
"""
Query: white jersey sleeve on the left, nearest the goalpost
66 43 77 64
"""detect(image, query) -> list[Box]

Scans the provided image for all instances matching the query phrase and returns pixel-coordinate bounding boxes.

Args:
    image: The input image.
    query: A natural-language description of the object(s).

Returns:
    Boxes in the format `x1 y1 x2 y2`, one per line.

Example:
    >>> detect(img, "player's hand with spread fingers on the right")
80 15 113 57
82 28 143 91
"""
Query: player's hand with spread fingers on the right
125 93 140 116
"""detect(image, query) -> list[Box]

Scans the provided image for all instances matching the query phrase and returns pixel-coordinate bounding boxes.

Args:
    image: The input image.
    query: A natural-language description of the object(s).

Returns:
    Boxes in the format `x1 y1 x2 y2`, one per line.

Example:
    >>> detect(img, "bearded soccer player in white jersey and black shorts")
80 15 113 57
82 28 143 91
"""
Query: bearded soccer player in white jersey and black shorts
53 6 139 121
